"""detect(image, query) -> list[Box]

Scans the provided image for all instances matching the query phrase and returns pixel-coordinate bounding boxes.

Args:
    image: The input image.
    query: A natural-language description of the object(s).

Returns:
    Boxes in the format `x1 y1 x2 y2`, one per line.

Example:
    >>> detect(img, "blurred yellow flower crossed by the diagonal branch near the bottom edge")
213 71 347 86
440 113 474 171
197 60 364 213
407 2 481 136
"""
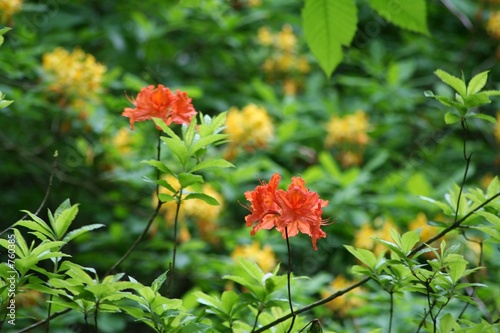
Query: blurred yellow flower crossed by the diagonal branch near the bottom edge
321 275 364 316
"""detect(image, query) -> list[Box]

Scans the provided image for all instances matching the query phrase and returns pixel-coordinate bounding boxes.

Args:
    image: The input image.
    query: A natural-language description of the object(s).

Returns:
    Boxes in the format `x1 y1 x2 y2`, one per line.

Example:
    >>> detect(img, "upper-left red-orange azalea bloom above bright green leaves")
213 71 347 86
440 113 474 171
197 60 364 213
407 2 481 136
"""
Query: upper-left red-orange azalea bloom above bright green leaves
122 84 196 129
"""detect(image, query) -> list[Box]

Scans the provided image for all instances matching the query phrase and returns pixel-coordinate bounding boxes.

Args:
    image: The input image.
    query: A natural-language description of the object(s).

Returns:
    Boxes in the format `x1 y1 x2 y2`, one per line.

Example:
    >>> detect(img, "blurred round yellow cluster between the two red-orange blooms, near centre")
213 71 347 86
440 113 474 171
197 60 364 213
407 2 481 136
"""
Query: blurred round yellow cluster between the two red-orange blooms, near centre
225 104 274 158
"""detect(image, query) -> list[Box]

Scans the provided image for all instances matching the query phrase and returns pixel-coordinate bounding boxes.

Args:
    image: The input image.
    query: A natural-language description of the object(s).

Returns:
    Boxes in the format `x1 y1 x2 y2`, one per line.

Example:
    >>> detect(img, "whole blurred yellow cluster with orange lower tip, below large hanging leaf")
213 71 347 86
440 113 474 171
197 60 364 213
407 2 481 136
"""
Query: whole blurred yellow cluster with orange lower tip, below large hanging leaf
325 110 370 167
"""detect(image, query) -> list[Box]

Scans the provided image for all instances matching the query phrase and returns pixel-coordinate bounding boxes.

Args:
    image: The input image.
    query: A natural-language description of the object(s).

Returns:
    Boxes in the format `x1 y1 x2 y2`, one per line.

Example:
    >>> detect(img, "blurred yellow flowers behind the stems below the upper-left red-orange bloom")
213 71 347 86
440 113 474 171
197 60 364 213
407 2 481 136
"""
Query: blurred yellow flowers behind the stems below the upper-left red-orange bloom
154 175 223 243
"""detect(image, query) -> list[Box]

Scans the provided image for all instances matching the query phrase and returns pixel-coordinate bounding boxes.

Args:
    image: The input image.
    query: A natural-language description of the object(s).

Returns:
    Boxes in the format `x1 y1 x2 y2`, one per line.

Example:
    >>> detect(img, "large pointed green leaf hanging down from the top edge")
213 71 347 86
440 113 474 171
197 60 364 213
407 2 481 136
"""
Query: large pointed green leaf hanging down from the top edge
302 0 358 76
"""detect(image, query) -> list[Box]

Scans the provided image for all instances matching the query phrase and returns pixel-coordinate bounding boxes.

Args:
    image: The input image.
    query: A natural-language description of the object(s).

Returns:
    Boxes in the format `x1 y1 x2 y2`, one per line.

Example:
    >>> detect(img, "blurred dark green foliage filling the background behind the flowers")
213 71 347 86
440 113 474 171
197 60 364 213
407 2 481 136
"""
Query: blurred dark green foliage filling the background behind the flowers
0 0 500 332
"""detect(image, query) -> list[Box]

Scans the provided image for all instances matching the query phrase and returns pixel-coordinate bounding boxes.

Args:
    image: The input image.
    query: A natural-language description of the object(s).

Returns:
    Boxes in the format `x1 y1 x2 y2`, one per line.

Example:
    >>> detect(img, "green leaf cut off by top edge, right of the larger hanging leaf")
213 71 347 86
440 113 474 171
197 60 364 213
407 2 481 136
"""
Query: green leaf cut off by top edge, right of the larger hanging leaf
368 0 429 35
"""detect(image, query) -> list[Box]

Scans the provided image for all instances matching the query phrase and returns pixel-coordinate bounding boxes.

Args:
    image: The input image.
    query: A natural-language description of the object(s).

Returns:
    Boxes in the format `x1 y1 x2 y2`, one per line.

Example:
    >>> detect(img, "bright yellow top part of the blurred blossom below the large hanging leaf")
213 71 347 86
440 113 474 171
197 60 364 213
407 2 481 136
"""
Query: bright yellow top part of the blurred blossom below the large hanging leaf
325 110 370 147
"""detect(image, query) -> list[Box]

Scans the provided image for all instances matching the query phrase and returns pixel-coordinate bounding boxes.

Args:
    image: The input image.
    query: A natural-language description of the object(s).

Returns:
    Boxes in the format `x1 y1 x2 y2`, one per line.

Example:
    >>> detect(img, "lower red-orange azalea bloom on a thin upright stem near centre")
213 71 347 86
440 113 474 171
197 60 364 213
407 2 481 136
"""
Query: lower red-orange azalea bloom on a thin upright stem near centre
245 173 328 250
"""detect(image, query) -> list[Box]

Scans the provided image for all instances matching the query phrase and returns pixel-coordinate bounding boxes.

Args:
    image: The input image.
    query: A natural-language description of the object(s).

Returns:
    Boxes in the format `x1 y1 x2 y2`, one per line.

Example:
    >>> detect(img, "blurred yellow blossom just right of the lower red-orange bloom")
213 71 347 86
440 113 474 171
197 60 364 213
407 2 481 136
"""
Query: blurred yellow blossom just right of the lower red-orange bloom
354 218 397 255
